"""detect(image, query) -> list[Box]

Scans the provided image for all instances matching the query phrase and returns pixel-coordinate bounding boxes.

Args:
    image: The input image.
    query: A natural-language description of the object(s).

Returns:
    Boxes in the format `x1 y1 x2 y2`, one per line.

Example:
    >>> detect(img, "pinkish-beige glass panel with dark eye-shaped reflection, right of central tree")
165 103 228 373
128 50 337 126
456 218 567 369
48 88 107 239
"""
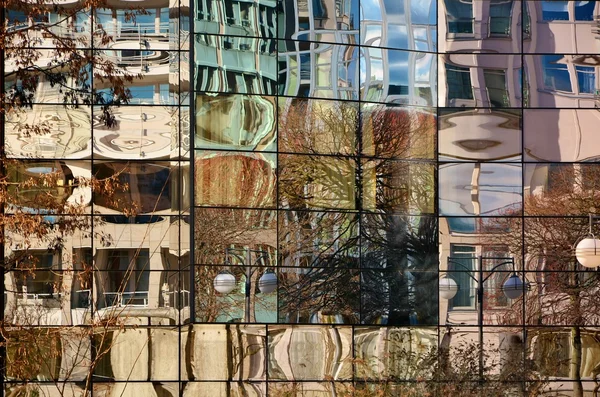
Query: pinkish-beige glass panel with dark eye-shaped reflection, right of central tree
438 109 520 161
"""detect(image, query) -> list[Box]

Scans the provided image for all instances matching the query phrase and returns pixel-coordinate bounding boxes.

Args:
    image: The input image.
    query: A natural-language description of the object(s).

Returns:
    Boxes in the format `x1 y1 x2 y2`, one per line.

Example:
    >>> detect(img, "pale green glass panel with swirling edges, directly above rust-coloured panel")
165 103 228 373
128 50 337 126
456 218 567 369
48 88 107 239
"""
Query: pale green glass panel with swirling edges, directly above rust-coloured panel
195 95 277 151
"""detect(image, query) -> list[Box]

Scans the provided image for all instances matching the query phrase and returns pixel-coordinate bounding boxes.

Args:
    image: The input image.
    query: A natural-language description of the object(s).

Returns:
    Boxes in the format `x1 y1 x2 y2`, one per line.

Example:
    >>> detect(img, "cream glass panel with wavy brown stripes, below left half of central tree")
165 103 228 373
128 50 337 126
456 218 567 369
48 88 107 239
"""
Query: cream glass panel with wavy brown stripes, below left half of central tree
268 326 352 381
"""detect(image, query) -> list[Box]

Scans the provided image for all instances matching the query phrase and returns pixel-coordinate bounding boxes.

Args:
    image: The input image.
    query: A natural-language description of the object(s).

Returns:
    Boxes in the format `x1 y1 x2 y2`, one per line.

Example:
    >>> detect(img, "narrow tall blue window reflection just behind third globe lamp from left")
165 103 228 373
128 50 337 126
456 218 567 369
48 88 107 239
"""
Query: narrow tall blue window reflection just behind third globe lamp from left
448 245 476 307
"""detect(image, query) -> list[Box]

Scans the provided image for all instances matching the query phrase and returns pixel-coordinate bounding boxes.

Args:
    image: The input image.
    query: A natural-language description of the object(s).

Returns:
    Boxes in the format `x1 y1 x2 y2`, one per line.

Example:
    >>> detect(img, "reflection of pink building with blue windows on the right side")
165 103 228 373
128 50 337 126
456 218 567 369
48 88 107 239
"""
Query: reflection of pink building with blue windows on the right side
438 0 600 395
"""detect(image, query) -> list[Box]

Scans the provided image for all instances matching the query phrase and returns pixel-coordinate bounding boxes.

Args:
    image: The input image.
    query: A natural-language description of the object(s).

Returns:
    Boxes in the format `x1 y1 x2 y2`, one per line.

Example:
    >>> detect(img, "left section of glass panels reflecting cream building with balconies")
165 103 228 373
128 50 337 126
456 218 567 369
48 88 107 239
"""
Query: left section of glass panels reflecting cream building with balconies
3 0 191 396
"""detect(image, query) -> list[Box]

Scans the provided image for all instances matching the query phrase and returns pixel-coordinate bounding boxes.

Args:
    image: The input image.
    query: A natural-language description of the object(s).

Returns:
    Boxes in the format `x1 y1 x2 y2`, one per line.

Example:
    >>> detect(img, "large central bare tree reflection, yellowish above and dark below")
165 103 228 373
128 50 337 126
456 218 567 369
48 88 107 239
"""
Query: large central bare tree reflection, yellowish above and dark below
279 101 437 324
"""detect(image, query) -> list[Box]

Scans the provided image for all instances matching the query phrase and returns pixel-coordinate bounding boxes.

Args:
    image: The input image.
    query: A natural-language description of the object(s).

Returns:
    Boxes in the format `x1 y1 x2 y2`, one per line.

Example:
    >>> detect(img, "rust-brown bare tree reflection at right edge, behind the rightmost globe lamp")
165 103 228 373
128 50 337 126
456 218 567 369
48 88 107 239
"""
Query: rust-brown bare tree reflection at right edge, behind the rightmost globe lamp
484 164 600 396
